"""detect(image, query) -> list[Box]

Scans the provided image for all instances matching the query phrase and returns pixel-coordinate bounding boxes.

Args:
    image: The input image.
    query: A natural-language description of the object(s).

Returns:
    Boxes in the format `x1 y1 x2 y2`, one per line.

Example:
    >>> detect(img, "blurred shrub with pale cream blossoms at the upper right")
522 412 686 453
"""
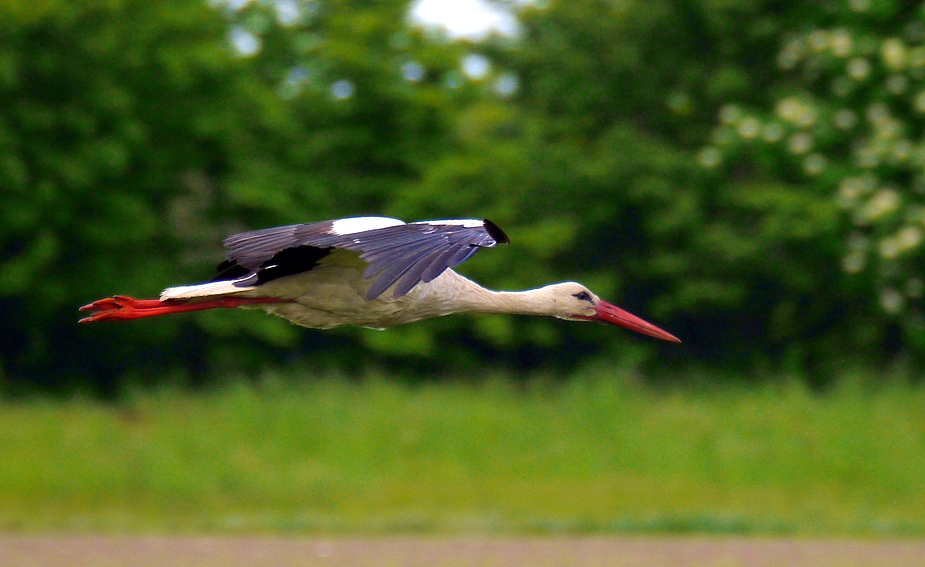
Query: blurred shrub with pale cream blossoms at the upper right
698 0 925 322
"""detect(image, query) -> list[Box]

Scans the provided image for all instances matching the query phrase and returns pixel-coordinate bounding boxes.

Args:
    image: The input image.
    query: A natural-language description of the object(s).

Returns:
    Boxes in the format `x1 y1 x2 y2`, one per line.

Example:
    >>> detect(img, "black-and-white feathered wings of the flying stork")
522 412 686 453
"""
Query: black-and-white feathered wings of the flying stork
217 217 508 300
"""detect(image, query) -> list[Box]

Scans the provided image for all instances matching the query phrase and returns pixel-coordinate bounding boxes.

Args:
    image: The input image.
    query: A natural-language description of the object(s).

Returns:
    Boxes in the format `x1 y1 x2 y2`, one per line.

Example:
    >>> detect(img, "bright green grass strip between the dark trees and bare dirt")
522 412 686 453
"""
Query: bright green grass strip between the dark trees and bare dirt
0 372 925 536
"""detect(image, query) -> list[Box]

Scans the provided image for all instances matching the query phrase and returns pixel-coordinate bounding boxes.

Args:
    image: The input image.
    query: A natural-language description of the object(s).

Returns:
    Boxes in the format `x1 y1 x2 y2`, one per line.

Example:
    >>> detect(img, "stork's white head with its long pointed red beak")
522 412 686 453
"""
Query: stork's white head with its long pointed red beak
542 282 681 343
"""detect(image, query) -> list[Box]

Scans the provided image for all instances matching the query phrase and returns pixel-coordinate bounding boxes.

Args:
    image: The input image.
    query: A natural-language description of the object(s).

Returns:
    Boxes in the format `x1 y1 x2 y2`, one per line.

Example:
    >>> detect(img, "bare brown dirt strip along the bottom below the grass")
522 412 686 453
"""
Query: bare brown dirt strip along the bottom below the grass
0 535 925 567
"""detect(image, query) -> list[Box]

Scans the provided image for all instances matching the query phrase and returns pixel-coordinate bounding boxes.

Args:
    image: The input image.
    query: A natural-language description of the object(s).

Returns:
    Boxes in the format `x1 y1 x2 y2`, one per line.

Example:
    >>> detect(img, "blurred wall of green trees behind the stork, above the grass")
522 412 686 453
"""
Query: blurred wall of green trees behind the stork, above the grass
0 0 925 394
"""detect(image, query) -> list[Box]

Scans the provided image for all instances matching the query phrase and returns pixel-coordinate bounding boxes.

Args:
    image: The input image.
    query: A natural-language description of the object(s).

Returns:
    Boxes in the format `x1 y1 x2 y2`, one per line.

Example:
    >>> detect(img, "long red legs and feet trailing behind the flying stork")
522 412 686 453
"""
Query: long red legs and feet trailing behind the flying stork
79 295 292 323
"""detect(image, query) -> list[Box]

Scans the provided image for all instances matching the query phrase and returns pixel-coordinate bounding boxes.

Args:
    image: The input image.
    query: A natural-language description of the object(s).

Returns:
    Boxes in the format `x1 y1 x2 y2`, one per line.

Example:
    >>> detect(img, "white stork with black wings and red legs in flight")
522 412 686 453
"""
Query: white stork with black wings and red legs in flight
80 217 681 342
